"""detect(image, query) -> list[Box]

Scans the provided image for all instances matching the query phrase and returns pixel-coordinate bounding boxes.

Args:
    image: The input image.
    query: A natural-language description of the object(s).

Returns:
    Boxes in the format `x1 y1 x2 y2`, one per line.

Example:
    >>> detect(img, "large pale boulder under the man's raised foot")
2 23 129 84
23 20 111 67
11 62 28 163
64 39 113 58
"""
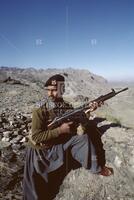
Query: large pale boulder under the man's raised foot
56 123 134 200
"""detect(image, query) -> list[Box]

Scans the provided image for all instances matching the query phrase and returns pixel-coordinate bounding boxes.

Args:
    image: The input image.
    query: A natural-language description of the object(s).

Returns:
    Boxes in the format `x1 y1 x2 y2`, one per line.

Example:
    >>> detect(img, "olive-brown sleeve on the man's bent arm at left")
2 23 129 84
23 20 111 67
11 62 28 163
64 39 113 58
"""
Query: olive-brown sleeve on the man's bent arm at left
31 110 59 144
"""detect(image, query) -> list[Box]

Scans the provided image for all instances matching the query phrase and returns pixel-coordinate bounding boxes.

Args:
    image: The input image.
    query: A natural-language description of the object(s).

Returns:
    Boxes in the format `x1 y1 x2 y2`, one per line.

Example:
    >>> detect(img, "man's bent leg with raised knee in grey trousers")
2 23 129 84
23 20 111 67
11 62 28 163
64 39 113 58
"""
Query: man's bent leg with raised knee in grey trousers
63 134 101 173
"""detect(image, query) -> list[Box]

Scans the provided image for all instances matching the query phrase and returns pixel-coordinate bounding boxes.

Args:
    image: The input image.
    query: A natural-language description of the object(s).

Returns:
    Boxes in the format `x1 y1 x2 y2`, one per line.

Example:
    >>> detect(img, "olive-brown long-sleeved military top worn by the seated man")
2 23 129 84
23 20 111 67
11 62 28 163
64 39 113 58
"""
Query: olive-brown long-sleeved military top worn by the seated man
29 98 73 147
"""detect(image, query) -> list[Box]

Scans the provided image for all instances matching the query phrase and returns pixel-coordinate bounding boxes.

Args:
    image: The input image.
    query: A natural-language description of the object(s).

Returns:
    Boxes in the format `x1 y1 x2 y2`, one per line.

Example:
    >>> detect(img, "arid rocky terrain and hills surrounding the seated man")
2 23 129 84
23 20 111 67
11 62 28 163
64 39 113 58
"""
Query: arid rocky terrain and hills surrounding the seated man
0 67 134 200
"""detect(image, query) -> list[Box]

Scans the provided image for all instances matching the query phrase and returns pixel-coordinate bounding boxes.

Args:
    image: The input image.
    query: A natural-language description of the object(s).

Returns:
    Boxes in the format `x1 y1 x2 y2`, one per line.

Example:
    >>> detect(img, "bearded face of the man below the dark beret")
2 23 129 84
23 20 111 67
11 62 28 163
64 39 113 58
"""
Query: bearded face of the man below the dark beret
47 84 64 100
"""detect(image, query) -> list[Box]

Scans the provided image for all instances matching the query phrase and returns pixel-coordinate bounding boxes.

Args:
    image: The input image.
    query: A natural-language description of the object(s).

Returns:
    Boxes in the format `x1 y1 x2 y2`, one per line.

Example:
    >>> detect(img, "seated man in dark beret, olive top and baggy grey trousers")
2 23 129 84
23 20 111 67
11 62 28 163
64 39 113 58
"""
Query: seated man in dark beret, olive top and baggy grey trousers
23 74 113 200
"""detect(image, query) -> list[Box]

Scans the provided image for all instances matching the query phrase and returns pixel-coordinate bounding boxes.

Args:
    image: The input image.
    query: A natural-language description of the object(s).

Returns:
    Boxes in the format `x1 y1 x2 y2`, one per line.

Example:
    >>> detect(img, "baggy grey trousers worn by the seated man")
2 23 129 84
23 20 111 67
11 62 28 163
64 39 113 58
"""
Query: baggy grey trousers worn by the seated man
23 134 100 200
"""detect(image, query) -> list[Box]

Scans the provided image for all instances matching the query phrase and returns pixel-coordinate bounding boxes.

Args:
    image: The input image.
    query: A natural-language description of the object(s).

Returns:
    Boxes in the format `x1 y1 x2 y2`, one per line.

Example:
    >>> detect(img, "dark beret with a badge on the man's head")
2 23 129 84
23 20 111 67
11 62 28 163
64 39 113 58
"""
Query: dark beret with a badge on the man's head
44 74 65 87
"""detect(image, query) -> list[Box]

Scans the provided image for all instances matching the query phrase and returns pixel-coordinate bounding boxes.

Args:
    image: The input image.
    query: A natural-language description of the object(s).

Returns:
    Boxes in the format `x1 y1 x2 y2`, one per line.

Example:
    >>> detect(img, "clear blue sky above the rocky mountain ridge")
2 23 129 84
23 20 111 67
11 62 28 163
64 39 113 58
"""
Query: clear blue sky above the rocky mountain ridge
0 0 134 81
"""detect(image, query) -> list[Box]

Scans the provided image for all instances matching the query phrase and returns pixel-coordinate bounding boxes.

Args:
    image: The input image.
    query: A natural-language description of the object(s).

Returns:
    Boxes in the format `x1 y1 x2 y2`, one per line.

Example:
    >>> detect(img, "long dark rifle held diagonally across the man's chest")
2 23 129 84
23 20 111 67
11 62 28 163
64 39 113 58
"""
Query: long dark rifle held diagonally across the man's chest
48 88 128 129
